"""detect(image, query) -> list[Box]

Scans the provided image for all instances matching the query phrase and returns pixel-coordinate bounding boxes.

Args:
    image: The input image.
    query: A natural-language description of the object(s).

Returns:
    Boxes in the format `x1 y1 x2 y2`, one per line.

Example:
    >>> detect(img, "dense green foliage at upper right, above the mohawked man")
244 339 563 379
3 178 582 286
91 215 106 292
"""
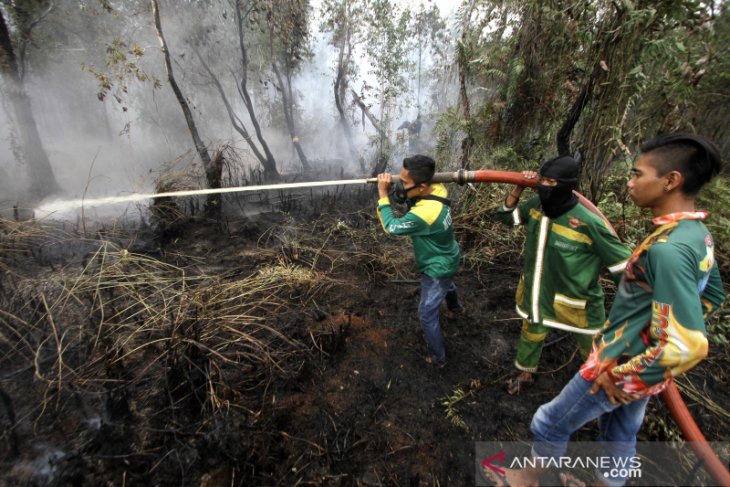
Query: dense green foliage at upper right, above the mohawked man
440 0 730 202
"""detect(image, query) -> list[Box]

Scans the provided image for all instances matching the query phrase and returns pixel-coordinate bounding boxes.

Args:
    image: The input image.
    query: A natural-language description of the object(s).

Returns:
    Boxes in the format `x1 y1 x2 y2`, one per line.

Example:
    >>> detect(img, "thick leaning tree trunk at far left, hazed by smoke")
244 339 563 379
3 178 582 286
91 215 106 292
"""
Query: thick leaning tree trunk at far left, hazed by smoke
0 10 60 199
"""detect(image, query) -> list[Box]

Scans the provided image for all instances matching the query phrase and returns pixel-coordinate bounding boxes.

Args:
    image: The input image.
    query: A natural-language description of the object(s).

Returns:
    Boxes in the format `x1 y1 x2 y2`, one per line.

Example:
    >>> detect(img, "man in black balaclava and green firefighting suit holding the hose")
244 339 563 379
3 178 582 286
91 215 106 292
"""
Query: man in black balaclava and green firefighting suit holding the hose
497 156 630 394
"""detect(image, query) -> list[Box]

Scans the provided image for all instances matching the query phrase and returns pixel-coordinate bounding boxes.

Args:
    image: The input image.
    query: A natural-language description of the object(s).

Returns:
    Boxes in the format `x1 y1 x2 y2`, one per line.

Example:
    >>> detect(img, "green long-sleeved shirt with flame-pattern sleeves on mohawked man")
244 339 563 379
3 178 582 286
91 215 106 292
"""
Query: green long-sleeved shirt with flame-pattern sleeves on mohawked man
580 212 725 395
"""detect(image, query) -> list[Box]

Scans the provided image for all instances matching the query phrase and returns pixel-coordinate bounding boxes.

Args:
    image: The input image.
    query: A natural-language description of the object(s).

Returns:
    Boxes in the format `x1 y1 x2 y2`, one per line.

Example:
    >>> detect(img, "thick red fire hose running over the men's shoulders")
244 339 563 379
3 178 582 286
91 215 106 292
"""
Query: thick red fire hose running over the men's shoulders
367 169 730 486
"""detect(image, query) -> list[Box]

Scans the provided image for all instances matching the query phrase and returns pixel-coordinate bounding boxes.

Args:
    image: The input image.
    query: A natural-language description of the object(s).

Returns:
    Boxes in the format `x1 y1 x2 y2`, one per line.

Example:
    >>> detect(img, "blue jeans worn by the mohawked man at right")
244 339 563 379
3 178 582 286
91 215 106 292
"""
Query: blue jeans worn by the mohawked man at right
530 374 649 487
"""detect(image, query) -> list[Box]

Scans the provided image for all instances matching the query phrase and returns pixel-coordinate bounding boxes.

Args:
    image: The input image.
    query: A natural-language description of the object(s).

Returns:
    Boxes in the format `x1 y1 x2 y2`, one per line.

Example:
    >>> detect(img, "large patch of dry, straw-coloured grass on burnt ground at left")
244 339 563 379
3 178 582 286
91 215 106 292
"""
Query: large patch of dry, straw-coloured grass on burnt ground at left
0 220 342 430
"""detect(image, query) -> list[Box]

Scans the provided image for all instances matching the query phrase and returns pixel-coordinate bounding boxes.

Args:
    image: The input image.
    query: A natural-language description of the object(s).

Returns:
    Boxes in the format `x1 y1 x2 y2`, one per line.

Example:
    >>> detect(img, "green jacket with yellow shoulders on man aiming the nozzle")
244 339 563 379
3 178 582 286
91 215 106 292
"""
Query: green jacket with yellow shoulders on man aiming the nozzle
378 184 461 278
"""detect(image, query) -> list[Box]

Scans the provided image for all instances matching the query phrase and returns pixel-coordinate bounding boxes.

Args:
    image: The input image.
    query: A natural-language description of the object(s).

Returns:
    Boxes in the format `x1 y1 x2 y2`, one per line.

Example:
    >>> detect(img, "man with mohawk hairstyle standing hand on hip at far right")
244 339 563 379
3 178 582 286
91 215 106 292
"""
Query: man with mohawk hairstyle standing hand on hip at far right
484 133 725 487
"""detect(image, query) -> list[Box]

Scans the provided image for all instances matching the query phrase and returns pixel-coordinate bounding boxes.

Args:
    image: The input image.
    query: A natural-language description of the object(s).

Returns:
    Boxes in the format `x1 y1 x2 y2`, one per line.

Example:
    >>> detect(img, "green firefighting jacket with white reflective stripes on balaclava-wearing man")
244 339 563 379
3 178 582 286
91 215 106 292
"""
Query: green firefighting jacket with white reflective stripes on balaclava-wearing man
497 196 631 331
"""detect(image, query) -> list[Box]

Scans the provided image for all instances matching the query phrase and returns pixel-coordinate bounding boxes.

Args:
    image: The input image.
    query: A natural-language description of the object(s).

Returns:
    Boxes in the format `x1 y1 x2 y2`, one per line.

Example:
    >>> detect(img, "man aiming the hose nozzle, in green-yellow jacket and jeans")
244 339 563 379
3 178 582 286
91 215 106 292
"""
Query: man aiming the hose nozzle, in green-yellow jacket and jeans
378 155 464 367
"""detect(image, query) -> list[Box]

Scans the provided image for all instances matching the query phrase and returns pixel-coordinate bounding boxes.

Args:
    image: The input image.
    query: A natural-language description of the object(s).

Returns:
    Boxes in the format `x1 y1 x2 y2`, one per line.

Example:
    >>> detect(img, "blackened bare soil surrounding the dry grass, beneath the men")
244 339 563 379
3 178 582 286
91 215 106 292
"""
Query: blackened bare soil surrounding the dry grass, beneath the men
0 188 730 487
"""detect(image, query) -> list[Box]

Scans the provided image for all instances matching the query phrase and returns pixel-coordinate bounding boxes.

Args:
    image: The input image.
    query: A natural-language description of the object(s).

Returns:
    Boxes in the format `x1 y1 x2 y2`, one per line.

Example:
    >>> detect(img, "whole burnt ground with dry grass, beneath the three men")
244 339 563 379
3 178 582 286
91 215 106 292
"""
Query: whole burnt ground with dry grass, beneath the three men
0 187 728 486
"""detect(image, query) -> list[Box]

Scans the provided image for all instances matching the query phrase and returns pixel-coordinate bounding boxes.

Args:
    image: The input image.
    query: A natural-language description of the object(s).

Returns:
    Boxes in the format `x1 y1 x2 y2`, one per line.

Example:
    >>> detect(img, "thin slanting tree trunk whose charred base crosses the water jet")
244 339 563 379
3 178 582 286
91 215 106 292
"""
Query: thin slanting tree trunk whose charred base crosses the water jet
151 0 222 218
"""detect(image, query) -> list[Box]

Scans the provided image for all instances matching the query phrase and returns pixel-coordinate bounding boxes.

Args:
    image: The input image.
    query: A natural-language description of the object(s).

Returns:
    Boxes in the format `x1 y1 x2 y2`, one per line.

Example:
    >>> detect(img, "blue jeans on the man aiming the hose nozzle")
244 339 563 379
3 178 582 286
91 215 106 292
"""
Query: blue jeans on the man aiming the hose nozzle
418 274 462 365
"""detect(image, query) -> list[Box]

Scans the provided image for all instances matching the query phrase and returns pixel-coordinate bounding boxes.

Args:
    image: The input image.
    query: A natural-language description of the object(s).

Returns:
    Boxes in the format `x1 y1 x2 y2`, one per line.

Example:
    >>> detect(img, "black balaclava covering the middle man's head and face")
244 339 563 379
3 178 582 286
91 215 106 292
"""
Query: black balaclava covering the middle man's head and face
535 156 578 218
